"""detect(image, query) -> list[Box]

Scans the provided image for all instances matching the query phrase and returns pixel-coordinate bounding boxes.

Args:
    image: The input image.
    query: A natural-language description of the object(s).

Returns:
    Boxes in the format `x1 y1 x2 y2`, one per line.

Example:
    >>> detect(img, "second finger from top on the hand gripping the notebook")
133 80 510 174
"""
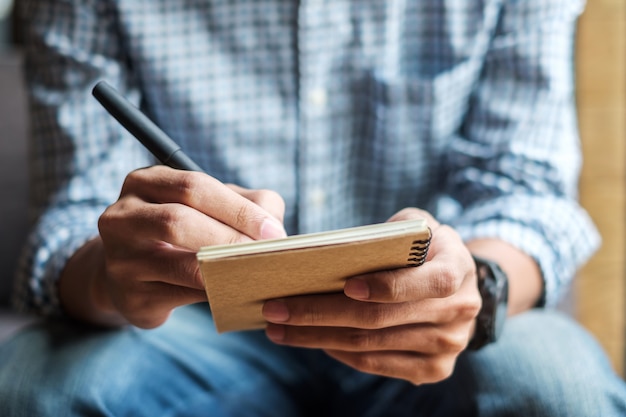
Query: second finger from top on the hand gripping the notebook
262 293 480 329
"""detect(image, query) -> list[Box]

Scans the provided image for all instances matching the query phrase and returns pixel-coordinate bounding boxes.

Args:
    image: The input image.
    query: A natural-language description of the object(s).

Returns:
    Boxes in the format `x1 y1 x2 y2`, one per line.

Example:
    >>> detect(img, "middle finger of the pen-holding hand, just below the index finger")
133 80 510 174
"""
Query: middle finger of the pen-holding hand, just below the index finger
98 196 251 251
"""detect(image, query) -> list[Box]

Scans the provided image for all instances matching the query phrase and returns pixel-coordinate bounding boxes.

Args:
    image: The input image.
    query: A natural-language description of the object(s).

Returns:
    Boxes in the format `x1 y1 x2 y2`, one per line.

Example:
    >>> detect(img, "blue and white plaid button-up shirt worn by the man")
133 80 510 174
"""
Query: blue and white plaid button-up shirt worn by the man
15 0 599 314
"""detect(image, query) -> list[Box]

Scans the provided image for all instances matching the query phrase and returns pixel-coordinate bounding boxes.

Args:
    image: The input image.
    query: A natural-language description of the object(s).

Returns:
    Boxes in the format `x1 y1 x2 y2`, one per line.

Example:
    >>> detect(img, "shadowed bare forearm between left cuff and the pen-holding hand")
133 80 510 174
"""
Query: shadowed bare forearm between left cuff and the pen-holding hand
58 238 127 327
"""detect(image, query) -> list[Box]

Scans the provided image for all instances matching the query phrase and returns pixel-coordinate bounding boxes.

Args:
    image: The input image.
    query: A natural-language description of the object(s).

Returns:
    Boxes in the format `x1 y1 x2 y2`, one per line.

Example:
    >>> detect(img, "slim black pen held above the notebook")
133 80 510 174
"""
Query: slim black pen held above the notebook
92 81 204 172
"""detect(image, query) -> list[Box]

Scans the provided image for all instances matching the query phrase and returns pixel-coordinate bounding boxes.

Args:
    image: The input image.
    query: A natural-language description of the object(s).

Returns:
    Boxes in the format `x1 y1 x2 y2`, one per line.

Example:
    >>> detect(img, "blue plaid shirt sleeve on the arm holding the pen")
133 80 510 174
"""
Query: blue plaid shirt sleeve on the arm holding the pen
13 0 151 315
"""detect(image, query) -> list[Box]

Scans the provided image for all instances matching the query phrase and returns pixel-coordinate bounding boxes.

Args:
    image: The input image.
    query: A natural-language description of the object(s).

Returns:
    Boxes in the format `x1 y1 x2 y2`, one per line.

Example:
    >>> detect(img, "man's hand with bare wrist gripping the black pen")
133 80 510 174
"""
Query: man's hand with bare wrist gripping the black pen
60 166 285 328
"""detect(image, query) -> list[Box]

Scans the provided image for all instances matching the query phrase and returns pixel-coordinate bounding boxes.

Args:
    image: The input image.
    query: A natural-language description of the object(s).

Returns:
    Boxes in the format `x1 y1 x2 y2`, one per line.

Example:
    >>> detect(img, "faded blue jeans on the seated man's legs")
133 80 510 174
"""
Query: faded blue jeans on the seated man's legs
0 305 626 417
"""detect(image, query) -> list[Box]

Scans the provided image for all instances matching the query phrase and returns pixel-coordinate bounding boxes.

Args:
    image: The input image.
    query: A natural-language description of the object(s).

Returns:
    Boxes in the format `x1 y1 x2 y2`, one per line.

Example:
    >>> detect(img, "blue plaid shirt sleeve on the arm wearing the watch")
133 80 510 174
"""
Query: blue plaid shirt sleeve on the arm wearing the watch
446 0 600 304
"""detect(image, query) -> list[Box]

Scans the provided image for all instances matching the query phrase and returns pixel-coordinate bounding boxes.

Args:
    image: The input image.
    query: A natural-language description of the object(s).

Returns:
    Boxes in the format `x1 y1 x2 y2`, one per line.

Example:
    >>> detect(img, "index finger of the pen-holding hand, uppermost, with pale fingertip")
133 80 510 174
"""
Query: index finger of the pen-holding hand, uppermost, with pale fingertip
122 165 286 240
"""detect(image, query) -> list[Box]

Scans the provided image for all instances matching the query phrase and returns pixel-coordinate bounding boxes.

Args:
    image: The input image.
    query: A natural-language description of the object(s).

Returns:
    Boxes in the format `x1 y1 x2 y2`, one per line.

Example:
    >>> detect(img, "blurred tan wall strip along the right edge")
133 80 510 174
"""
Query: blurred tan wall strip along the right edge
574 0 626 376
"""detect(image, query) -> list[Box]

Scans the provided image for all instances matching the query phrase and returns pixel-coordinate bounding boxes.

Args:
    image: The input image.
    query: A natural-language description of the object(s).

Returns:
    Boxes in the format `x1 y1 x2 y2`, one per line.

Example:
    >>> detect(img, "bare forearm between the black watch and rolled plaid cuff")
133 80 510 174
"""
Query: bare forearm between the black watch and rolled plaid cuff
467 239 543 315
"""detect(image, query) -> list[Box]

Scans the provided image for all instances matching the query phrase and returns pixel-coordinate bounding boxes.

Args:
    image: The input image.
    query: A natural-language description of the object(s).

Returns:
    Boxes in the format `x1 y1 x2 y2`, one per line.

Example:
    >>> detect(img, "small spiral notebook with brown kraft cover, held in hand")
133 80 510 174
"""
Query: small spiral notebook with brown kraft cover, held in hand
198 220 430 332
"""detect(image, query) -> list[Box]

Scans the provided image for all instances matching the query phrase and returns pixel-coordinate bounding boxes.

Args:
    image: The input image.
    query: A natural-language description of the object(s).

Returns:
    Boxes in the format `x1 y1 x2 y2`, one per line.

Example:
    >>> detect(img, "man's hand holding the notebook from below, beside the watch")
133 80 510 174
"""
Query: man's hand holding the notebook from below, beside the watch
263 209 481 384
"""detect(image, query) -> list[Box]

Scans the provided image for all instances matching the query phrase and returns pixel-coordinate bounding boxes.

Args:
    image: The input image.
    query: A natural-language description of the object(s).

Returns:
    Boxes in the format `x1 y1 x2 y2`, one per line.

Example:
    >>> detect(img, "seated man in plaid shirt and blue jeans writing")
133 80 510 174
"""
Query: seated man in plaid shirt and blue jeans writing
0 0 626 416
